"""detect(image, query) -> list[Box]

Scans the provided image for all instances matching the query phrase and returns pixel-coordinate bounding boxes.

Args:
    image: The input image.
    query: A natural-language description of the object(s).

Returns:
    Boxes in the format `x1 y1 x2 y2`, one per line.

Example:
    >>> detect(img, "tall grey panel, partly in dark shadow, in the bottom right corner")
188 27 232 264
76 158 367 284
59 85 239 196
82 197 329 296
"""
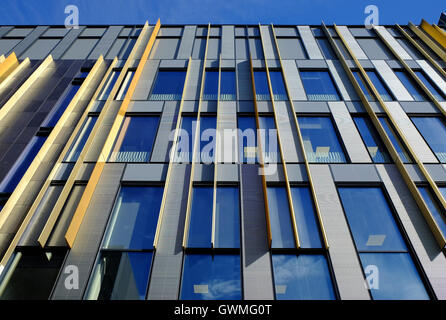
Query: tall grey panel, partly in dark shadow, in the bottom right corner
376 164 446 300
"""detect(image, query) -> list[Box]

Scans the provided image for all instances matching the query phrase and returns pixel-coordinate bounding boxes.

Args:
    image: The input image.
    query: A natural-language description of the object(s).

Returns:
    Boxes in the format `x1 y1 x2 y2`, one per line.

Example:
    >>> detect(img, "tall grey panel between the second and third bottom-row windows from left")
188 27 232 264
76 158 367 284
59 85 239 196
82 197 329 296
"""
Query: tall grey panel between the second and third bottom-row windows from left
148 164 191 300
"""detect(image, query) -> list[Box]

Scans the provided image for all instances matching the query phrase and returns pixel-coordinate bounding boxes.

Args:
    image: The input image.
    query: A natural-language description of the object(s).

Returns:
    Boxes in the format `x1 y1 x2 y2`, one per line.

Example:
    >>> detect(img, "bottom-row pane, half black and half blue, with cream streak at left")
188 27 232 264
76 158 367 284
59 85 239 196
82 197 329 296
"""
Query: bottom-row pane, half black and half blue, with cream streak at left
86 251 152 300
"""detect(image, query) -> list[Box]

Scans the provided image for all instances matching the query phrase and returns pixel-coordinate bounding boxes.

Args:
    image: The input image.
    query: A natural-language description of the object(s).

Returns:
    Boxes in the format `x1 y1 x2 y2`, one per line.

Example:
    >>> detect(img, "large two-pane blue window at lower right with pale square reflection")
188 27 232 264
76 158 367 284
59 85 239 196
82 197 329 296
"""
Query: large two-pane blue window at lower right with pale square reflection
338 187 429 300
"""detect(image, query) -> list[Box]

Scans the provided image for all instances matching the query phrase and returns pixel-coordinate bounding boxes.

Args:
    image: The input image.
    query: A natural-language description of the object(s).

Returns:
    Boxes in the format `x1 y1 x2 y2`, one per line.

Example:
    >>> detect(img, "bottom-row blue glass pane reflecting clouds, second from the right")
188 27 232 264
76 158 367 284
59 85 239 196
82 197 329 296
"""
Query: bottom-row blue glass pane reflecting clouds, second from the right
272 254 336 300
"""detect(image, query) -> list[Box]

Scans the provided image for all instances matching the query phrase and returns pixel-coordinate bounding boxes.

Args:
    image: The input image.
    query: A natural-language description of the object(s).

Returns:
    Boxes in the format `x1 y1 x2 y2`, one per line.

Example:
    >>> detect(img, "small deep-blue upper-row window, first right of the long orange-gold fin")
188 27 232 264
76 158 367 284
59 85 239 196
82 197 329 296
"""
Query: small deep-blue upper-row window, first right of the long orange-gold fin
149 70 186 100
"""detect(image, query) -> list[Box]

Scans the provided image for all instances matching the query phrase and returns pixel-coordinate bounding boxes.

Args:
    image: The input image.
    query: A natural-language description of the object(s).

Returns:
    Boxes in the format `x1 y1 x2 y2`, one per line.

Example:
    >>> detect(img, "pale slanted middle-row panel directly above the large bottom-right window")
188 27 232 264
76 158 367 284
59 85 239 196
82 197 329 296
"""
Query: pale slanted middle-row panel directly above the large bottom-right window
328 101 372 163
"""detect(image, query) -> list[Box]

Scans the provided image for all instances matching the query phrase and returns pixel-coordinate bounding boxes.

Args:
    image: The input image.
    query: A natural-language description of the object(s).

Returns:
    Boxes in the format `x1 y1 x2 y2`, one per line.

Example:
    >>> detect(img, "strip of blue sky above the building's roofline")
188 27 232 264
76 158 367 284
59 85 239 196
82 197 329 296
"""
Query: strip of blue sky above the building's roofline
0 0 446 25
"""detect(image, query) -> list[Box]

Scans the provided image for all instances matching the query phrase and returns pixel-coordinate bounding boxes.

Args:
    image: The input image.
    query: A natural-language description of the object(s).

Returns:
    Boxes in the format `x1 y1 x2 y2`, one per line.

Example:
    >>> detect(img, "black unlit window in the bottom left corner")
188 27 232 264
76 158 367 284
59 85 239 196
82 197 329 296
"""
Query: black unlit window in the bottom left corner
0 250 65 300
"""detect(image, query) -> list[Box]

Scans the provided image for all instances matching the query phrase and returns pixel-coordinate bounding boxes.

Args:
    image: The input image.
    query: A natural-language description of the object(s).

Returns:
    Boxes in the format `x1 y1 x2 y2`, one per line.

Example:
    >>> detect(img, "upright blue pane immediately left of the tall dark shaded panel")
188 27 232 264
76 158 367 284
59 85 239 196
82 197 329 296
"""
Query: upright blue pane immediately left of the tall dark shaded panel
215 187 240 248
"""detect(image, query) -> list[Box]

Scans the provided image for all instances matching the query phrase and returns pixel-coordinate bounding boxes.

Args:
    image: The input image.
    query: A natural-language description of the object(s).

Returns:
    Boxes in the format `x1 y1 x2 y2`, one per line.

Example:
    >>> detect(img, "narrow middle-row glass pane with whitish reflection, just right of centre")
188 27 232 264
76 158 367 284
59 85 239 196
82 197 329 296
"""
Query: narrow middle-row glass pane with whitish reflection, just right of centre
259 117 280 163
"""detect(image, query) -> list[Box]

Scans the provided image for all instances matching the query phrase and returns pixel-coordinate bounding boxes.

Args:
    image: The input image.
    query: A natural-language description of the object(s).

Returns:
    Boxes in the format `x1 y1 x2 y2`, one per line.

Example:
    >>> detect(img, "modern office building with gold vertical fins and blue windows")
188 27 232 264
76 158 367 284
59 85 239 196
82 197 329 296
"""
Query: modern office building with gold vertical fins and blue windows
0 16 446 300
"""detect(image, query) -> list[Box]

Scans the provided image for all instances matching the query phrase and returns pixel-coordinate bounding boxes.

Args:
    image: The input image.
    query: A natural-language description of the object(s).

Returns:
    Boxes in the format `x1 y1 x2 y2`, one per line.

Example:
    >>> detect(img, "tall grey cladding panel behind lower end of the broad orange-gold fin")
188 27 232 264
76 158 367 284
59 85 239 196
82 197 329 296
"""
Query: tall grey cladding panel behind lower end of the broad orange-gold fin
51 163 125 300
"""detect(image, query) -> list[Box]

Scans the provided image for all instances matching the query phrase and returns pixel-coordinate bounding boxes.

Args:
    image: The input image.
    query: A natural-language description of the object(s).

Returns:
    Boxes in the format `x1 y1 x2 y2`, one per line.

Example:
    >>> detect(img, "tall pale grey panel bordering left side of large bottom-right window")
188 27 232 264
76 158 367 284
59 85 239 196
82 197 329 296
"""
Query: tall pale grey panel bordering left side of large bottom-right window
310 164 370 300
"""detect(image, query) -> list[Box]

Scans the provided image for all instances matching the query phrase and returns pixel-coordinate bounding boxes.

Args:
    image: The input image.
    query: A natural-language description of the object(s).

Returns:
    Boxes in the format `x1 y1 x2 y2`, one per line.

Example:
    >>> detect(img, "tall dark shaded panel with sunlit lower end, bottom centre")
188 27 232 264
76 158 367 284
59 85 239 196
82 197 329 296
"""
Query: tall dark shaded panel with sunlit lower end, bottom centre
240 165 274 300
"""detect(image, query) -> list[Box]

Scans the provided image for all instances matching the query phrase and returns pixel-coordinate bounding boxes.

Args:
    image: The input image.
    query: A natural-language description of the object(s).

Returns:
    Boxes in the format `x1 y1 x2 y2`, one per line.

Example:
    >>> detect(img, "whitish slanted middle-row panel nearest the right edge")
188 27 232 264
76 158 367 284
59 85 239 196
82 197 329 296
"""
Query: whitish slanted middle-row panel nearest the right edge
386 102 438 163
